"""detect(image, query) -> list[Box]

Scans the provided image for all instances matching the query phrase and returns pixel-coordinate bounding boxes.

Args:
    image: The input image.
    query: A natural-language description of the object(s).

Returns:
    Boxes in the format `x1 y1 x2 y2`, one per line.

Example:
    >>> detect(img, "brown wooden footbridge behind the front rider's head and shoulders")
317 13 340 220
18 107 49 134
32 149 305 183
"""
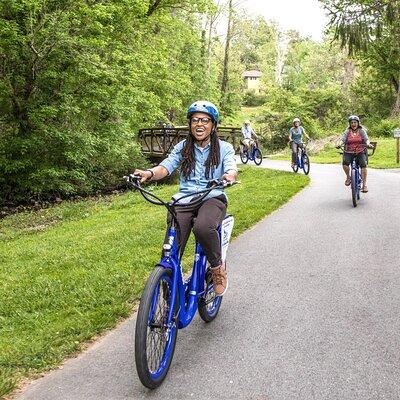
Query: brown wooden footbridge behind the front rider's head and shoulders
139 126 242 159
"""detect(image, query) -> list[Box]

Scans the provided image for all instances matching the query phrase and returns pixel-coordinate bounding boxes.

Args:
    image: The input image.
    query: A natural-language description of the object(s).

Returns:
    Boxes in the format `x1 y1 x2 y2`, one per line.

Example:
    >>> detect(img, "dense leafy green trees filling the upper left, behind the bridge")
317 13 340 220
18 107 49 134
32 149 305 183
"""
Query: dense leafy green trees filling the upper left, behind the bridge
0 0 228 204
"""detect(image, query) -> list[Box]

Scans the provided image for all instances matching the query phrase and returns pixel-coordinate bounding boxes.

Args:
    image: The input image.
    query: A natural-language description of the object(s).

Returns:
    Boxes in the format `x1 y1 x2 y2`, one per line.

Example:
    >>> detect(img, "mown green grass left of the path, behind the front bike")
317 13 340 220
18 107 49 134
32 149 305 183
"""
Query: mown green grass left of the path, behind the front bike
0 167 308 395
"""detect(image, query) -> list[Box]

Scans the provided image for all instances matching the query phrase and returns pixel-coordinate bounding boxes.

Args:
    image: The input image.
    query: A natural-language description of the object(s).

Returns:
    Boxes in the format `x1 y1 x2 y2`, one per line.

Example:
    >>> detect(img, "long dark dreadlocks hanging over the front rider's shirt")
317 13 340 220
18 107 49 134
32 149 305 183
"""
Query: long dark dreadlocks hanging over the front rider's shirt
181 127 220 179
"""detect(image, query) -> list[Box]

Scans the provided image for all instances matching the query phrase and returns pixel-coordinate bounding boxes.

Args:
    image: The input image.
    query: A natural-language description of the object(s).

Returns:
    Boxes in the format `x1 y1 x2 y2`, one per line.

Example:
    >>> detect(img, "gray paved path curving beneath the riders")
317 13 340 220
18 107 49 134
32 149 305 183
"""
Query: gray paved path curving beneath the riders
17 161 400 400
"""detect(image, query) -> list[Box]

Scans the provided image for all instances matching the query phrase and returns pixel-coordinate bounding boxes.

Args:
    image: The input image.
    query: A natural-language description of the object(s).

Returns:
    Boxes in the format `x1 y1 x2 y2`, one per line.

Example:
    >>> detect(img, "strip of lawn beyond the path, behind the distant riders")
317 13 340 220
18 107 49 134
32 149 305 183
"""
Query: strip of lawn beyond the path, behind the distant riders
269 138 400 168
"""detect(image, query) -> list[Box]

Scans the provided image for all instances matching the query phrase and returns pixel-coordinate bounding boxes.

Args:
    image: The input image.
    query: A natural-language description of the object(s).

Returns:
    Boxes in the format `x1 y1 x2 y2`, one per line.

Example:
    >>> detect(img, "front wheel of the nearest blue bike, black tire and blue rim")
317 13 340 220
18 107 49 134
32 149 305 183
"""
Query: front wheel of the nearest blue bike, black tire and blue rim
135 267 178 389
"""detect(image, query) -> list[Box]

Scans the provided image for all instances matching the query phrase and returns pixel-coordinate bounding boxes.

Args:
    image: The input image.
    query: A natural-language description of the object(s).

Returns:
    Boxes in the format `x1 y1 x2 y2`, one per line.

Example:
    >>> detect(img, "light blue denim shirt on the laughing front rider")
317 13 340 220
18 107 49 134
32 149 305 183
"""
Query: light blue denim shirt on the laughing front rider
160 140 237 203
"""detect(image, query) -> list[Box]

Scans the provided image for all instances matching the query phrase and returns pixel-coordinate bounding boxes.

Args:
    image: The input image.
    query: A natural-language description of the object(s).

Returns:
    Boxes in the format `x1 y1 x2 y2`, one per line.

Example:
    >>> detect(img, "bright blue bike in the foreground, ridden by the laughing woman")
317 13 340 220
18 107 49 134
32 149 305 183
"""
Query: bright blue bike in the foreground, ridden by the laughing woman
125 175 234 389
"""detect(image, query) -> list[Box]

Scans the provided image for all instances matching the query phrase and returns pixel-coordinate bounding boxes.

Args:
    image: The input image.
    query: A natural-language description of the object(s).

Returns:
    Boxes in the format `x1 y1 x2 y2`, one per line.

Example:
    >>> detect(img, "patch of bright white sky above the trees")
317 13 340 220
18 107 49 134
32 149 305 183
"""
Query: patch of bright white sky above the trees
240 0 328 40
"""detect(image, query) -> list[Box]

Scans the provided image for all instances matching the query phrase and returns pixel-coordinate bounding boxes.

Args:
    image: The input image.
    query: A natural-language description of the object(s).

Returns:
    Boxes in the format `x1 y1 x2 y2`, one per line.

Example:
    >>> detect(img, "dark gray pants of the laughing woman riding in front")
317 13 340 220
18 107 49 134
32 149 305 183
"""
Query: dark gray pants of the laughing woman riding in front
173 196 227 267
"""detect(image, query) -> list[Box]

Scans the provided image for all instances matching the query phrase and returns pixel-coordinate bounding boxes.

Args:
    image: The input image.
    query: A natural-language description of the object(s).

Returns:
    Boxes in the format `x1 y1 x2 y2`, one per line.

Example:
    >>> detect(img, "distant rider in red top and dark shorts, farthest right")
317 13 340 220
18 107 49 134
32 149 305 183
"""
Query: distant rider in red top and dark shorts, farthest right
341 115 371 193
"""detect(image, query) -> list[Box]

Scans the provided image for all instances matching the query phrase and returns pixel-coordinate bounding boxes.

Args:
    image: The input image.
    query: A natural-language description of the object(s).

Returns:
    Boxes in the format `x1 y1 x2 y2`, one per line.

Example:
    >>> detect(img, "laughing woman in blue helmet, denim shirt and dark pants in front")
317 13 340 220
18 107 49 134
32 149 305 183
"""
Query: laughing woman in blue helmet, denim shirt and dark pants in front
134 100 237 296
